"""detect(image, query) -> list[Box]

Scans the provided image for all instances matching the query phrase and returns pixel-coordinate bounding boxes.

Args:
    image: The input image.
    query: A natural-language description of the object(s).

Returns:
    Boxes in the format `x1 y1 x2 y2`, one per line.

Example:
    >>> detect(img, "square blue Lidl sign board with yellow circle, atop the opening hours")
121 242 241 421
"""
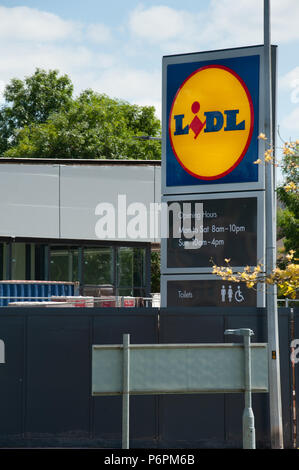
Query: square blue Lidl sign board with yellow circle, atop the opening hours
162 46 274 194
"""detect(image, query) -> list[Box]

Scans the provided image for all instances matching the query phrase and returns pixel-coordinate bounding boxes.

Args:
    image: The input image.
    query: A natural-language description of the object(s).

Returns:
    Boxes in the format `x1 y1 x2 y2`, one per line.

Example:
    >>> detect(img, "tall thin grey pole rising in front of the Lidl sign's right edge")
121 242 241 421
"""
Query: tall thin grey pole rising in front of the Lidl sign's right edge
264 0 283 449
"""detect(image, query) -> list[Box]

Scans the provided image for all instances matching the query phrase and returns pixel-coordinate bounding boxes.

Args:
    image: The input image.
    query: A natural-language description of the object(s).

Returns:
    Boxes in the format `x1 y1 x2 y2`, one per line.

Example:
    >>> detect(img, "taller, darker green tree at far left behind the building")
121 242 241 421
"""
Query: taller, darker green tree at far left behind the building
0 69 73 155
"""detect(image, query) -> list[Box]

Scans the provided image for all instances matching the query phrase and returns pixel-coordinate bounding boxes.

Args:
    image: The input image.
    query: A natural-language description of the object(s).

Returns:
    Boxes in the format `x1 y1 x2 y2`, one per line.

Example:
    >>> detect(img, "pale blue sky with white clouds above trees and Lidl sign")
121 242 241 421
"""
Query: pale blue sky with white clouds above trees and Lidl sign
0 0 299 174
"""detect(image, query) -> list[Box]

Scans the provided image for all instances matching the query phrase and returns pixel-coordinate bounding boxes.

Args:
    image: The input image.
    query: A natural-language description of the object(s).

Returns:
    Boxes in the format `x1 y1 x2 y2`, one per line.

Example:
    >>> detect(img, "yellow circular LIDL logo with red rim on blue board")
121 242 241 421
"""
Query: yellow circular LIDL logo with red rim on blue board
169 65 254 180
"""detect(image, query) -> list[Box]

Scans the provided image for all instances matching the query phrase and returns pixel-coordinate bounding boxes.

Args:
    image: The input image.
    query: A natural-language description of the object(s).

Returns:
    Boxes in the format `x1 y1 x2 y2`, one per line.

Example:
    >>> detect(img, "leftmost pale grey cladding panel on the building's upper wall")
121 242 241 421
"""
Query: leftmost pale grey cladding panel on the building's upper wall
0 164 59 238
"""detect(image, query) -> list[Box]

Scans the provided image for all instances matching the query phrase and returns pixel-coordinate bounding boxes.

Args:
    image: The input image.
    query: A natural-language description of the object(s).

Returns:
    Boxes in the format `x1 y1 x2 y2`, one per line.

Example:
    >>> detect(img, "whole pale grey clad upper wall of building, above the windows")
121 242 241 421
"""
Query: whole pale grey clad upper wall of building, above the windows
0 163 161 242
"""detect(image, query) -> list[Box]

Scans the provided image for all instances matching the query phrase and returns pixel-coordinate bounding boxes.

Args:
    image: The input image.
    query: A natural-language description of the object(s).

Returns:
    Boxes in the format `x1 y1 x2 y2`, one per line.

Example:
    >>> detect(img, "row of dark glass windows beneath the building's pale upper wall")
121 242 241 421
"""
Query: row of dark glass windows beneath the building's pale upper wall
0 241 148 297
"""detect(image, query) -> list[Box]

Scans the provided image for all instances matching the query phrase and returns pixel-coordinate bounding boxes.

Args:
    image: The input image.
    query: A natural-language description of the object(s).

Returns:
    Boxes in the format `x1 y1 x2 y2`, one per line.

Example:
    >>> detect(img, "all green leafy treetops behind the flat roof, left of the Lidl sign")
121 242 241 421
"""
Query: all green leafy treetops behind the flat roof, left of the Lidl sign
0 70 161 160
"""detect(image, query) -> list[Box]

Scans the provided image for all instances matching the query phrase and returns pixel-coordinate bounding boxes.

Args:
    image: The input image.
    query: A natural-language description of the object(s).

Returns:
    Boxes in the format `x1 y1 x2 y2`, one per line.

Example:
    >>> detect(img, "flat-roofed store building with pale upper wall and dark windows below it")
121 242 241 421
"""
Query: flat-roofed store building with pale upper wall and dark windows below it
0 159 161 297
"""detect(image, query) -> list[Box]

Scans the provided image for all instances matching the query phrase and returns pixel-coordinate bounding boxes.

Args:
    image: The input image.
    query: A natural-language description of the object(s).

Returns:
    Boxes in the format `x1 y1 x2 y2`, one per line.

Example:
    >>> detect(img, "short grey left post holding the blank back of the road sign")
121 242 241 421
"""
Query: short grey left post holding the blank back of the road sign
122 334 130 449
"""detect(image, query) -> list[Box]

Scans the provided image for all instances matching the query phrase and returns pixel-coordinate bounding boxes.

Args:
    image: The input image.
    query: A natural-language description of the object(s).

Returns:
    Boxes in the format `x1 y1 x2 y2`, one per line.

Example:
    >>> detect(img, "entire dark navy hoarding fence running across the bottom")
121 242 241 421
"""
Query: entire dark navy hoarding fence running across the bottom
0 307 299 448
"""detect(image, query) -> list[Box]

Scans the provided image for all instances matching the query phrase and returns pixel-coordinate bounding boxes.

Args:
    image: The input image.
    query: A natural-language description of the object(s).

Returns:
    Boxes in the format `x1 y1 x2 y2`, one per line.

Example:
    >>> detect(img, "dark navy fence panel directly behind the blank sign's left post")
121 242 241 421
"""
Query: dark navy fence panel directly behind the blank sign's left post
92 308 158 448
